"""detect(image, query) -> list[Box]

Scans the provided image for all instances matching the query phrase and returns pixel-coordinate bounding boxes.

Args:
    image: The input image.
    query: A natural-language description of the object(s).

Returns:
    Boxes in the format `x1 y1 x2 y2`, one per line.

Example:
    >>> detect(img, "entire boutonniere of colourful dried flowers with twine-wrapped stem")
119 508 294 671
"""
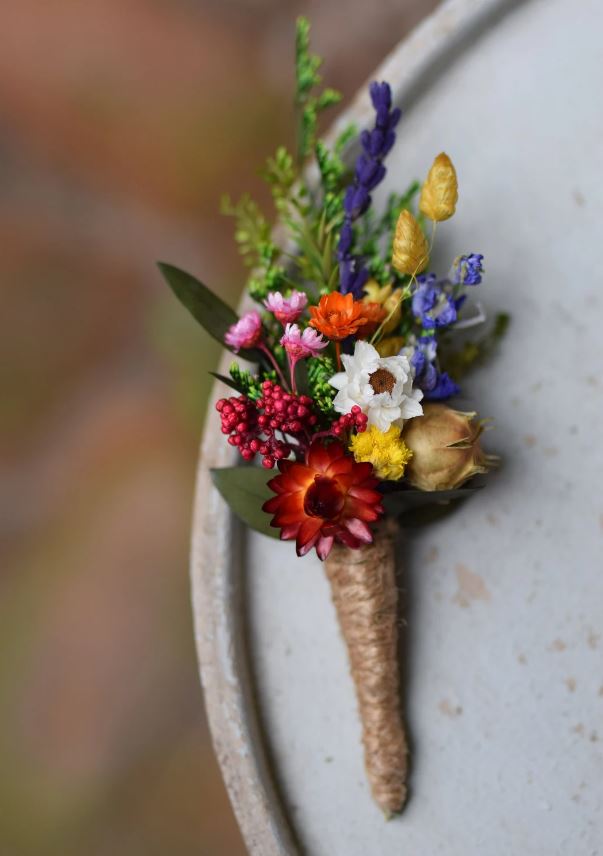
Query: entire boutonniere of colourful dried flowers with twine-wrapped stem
160 19 508 816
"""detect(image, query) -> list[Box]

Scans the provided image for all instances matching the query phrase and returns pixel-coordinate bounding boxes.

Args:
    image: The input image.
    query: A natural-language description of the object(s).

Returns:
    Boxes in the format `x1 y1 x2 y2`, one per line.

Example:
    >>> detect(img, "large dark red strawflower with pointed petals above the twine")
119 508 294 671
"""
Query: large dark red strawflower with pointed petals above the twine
262 440 383 559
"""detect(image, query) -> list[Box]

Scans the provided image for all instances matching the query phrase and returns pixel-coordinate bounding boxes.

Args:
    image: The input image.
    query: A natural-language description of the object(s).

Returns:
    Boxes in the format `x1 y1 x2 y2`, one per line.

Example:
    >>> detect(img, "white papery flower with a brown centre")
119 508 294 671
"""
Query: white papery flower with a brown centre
329 340 423 432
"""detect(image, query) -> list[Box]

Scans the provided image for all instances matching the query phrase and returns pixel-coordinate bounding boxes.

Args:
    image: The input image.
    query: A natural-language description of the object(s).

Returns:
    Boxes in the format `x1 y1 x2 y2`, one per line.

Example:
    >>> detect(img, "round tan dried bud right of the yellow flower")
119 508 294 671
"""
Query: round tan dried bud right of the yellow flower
403 404 498 490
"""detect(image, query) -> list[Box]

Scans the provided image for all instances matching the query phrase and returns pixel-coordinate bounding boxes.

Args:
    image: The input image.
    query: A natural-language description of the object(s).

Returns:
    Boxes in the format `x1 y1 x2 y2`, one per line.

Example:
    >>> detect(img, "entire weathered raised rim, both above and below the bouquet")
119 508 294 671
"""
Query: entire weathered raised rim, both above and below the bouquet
190 0 519 856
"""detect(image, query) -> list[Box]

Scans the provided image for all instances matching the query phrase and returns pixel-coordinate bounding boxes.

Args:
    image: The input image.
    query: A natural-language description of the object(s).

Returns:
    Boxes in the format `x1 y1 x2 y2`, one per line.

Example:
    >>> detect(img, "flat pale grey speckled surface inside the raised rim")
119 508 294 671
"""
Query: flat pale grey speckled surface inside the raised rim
246 0 603 856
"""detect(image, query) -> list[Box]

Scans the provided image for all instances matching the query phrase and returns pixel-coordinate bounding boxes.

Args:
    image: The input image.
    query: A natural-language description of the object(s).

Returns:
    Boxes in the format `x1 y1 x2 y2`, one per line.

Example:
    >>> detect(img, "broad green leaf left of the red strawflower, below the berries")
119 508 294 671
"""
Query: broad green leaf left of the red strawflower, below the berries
211 467 279 538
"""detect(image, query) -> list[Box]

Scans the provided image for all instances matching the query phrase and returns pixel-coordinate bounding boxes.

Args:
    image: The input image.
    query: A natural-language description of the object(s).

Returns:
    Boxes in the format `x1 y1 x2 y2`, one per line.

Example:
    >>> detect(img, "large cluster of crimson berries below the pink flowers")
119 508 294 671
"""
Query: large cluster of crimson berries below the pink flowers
216 380 318 469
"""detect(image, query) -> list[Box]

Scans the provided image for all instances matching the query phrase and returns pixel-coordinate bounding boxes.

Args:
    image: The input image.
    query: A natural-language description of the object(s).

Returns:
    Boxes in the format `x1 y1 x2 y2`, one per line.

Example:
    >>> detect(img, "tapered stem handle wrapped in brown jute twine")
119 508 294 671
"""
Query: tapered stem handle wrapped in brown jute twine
325 521 408 817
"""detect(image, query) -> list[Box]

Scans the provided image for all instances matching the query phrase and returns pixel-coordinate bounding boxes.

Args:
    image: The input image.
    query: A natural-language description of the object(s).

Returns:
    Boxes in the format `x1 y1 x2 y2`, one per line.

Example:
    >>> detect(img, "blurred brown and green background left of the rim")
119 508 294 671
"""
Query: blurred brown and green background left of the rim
0 0 436 856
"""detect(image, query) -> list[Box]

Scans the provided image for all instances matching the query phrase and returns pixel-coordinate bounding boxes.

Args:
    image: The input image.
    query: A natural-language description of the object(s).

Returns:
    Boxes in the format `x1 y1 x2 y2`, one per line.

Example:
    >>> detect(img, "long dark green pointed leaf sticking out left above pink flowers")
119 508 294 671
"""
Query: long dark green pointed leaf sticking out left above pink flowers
157 262 262 363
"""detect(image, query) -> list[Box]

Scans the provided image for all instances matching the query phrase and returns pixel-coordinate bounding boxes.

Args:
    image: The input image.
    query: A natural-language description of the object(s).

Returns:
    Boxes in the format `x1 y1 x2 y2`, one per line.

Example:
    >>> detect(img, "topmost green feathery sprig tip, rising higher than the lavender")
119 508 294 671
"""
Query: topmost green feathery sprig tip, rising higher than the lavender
295 17 341 164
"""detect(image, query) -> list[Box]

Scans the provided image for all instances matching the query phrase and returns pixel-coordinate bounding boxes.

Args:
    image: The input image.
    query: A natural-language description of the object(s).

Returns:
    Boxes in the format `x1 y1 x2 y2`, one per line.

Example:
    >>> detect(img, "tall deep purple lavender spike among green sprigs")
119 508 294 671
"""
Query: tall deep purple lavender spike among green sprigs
337 81 401 298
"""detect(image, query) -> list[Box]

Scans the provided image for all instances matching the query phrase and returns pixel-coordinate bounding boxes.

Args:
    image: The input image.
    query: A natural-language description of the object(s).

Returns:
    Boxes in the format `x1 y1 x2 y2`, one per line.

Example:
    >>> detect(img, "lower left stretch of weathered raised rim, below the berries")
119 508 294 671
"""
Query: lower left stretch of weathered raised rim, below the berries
190 354 298 856
